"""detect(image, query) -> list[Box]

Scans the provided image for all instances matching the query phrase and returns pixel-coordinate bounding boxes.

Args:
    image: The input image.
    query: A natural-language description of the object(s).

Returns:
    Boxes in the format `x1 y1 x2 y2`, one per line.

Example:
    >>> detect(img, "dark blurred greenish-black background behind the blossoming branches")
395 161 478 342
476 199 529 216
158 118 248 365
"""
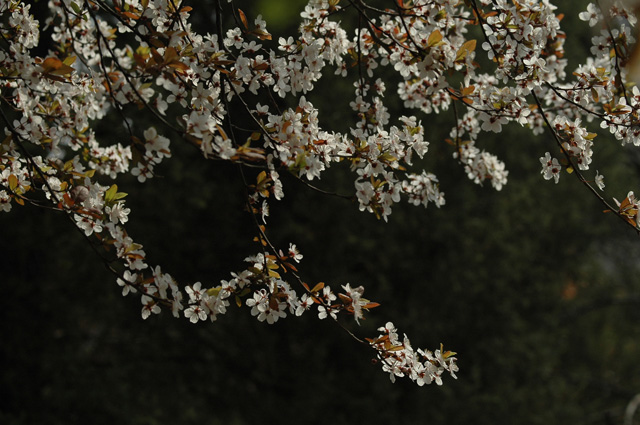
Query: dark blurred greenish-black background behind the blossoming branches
0 1 640 425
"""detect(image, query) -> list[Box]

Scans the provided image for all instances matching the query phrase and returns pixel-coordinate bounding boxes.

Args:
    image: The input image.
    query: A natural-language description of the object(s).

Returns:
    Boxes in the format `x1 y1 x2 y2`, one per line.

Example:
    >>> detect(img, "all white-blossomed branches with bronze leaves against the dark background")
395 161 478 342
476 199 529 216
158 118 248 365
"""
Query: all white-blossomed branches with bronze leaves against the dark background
0 0 640 384
